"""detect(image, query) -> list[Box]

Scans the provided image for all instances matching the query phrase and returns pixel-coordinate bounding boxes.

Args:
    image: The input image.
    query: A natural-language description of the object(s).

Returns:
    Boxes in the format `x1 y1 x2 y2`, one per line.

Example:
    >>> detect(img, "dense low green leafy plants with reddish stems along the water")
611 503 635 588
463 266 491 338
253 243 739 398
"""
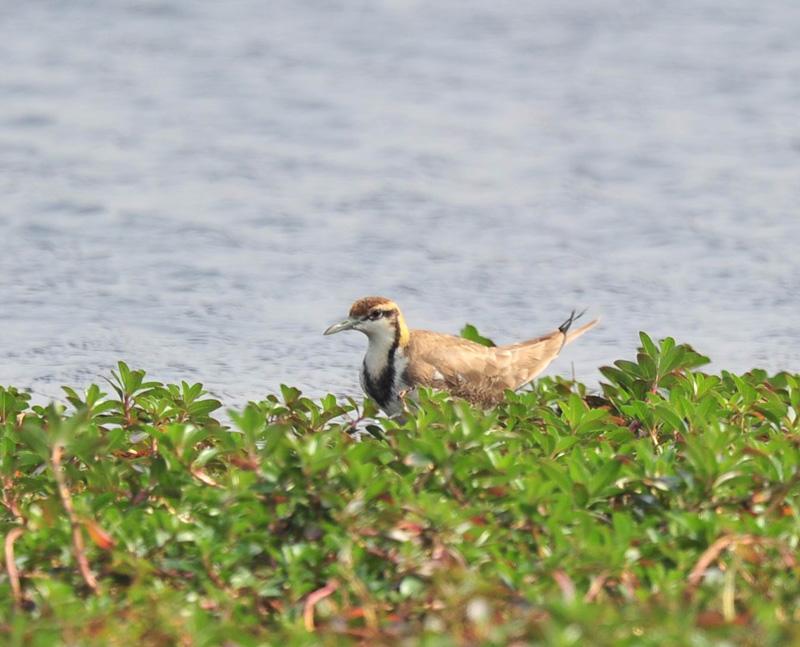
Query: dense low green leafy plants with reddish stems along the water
0 335 800 647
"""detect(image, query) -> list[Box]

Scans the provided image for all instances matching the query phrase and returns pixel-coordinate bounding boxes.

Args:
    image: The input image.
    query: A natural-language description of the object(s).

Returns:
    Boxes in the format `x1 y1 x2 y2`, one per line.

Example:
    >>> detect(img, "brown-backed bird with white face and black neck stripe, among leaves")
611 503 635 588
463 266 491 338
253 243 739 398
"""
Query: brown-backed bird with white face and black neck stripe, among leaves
323 297 599 417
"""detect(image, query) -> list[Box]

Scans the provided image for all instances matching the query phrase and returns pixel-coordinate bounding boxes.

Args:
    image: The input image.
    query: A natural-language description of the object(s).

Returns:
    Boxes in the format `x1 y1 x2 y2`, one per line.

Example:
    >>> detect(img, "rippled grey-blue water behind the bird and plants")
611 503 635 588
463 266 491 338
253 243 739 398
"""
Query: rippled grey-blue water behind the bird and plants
0 0 800 404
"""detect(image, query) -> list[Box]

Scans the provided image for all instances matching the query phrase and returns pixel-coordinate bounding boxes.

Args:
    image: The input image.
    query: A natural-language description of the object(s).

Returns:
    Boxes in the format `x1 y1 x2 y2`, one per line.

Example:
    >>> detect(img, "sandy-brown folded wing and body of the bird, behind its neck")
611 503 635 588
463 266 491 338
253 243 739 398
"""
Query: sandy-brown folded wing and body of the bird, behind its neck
407 320 597 405
